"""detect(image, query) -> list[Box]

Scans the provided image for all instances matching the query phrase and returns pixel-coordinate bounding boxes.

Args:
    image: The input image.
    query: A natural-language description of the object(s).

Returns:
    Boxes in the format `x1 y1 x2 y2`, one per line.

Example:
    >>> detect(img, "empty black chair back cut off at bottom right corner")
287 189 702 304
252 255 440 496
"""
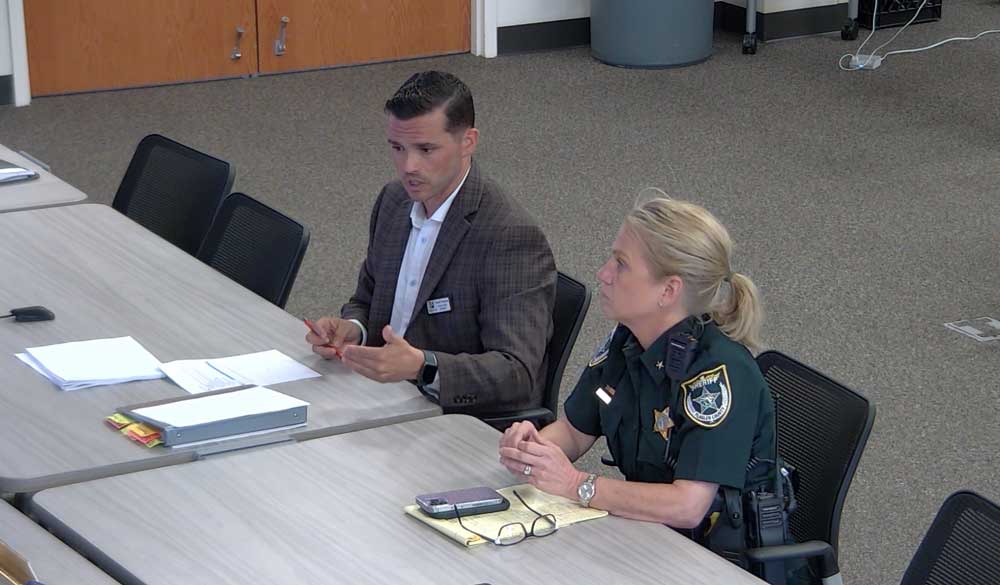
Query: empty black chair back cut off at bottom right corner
901 491 1000 585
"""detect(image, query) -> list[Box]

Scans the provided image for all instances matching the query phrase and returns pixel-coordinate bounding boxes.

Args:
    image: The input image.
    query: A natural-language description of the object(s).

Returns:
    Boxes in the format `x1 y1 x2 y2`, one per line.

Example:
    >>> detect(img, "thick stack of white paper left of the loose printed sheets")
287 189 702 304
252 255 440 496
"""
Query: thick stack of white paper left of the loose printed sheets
17 337 163 390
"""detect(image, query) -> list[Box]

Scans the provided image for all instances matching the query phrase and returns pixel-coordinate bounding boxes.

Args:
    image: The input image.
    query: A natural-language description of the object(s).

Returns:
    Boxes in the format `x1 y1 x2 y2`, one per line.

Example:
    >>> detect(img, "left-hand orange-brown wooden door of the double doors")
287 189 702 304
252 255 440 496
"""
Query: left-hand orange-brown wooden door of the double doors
24 0 257 96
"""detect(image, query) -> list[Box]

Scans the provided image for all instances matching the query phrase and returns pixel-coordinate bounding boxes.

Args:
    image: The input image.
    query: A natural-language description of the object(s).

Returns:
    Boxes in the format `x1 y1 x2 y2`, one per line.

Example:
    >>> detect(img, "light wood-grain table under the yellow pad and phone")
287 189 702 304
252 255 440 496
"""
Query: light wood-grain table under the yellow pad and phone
29 415 763 585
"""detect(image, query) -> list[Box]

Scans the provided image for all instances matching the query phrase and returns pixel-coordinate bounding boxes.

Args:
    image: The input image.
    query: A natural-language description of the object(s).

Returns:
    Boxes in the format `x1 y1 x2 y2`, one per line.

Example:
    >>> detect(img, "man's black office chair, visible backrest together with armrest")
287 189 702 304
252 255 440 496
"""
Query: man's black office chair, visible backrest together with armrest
483 272 590 429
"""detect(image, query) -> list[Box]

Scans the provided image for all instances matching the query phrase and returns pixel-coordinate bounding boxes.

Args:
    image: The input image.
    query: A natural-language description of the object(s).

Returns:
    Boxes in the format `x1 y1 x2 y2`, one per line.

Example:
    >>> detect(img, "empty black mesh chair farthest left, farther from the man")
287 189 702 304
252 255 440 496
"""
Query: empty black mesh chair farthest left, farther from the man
111 134 234 255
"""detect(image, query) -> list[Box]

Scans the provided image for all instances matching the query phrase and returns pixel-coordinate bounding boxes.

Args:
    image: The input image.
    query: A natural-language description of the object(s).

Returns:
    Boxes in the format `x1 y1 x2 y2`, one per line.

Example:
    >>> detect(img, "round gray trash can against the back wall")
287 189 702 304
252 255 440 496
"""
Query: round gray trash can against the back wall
590 0 715 68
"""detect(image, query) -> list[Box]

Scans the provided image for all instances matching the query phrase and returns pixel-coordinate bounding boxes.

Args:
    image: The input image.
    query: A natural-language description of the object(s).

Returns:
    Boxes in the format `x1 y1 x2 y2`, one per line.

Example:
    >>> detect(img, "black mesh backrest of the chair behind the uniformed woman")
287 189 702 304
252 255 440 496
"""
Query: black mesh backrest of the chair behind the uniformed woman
757 351 875 552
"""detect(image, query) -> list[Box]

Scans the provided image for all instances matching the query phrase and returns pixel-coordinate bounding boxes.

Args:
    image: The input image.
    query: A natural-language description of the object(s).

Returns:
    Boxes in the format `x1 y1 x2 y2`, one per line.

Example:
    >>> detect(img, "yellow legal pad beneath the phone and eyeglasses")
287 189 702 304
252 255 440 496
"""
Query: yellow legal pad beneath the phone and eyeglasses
403 484 608 546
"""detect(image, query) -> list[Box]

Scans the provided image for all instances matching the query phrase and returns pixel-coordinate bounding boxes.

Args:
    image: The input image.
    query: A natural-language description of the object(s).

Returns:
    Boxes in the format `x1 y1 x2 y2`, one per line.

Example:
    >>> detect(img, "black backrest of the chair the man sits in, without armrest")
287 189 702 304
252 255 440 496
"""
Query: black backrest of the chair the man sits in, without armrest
542 272 590 416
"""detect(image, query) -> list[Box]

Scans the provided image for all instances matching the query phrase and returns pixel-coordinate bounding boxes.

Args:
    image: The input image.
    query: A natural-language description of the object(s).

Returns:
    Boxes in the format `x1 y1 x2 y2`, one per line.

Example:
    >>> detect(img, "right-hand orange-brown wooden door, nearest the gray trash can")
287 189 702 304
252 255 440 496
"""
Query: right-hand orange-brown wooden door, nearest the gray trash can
257 0 470 73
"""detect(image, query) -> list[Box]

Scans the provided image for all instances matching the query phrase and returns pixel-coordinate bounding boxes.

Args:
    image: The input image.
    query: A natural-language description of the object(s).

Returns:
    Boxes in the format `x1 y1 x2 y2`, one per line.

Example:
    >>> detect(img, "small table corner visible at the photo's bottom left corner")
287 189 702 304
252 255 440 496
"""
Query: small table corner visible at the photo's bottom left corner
0 500 117 585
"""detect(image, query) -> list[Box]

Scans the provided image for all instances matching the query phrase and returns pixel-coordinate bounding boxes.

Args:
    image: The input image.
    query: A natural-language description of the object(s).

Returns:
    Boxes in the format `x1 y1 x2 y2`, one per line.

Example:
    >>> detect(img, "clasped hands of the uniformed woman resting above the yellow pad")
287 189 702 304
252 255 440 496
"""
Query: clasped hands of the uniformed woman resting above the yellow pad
500 421 587 500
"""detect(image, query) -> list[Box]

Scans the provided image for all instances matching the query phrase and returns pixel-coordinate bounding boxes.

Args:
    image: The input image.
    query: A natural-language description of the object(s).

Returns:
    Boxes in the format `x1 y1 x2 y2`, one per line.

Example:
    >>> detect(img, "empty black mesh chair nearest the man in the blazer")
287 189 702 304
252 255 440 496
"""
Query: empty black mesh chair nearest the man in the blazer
198 193 309 308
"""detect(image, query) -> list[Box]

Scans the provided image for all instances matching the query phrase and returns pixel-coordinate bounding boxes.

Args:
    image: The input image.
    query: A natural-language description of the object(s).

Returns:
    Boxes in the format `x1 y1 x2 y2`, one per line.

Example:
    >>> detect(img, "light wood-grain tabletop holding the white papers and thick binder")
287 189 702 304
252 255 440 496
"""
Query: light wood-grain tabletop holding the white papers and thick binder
0 204 441 493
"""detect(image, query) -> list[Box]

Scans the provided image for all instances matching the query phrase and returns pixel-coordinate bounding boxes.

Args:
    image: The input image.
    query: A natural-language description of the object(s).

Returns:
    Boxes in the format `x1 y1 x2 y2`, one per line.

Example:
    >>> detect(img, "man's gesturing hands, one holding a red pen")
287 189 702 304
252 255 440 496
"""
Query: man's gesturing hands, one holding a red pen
306 317 424 382
